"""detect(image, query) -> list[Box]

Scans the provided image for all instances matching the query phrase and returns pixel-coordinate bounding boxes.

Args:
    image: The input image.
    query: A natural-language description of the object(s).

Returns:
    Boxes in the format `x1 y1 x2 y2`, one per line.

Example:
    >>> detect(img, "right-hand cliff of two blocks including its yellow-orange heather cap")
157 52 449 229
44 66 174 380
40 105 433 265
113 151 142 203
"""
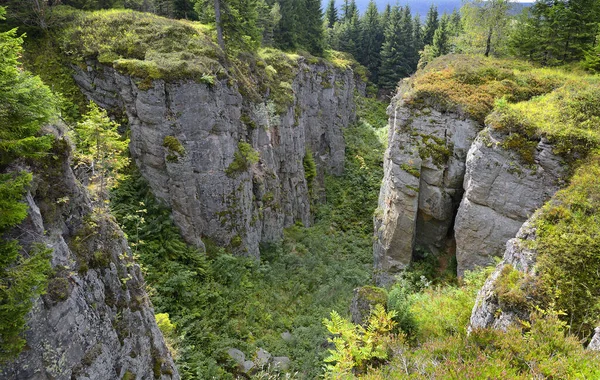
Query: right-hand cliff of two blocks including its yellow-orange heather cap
374 56 564 283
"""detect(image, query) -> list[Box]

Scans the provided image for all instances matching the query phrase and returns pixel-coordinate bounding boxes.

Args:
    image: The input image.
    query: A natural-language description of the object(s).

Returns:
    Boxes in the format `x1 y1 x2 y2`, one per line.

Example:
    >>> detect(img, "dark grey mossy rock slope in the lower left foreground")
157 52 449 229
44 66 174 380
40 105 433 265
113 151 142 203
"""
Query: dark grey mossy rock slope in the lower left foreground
0 132 179 380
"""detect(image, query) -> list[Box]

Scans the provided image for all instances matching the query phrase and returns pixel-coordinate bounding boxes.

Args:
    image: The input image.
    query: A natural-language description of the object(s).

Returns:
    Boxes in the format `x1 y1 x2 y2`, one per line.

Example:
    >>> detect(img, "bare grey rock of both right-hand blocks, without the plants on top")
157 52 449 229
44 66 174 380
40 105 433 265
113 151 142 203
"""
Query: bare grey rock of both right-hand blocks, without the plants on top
374 84 565 284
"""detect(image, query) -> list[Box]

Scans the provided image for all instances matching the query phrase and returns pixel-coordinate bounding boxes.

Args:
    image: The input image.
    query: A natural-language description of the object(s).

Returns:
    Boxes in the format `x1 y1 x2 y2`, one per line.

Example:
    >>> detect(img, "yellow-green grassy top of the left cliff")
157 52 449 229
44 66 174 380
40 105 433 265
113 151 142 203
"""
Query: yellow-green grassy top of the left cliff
52 7 226 81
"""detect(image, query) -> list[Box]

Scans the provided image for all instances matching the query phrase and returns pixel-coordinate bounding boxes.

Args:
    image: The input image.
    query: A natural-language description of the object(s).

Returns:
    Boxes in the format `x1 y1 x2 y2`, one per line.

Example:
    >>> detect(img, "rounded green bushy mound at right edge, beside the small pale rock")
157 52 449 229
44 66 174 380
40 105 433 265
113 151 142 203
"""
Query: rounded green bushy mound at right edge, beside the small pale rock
536 154 600 338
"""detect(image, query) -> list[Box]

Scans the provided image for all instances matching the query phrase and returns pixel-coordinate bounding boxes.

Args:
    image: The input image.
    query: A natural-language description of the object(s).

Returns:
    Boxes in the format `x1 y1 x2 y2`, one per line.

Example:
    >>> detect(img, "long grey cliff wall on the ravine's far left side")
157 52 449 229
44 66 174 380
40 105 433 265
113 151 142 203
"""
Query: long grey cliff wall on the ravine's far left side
75 62 356 256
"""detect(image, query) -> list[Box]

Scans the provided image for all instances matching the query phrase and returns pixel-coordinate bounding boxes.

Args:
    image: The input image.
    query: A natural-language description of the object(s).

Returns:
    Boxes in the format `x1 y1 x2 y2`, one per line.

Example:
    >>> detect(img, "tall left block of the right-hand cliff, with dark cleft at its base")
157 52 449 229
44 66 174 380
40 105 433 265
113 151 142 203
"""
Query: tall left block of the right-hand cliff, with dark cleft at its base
374 84 480 284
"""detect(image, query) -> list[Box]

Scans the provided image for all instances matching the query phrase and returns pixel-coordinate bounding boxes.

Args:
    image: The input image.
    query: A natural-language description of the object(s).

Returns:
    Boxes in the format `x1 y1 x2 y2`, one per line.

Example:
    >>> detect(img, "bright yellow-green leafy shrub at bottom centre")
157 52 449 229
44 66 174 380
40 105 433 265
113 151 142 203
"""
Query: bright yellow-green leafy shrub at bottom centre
323 304 396 379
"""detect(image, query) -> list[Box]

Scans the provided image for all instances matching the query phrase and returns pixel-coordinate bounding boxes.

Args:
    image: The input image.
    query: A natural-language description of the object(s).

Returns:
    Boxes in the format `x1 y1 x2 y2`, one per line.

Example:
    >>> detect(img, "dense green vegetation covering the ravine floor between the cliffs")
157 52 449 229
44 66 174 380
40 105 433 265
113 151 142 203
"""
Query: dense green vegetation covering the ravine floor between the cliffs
112 101 383 379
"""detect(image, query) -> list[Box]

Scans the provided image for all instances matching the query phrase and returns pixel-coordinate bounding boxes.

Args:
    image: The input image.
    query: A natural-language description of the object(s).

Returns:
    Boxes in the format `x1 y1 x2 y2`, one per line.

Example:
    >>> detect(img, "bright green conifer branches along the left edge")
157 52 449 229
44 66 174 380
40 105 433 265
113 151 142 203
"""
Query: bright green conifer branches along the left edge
0 7 56 363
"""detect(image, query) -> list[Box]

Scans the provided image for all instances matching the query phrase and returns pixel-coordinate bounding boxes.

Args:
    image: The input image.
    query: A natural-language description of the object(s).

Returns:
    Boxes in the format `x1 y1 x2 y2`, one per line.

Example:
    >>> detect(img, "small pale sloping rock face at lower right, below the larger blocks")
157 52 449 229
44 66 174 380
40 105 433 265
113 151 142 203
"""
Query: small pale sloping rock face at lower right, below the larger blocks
467 220 537 332
